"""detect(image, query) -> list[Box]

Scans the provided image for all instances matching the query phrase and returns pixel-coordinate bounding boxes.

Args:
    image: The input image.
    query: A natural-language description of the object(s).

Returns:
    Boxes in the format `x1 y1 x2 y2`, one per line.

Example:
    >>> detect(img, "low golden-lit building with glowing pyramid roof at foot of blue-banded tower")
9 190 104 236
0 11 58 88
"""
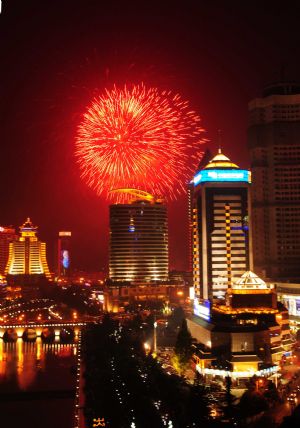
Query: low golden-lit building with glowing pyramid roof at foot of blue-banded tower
187 271 292 378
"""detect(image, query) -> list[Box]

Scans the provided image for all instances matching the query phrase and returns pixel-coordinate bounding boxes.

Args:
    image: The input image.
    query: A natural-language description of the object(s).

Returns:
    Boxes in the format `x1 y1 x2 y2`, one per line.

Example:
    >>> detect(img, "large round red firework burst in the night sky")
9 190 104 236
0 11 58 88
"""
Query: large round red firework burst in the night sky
75 84 203 199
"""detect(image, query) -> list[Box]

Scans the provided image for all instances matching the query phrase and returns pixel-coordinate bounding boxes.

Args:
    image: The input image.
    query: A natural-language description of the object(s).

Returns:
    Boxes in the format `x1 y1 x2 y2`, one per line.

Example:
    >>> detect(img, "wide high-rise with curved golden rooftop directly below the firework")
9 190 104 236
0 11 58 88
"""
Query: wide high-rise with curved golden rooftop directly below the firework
109 191 169 282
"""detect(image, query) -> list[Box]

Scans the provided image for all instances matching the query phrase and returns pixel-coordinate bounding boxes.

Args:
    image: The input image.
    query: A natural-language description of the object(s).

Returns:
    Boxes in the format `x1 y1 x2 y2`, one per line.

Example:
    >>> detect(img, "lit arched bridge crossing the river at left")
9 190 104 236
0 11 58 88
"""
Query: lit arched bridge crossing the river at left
0 322 87 340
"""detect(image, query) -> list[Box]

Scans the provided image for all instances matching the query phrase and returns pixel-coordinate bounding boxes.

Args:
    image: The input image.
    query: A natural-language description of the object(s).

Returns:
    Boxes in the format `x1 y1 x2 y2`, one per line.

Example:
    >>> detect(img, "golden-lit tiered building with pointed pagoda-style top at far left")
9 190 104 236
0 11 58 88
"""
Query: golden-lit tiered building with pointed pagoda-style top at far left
5 218 51 279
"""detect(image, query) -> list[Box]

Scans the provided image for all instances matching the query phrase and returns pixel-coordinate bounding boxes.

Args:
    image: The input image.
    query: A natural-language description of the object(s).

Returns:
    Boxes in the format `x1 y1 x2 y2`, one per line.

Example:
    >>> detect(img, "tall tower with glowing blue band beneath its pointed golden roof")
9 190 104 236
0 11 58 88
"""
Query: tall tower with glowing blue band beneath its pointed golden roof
190 150 252 301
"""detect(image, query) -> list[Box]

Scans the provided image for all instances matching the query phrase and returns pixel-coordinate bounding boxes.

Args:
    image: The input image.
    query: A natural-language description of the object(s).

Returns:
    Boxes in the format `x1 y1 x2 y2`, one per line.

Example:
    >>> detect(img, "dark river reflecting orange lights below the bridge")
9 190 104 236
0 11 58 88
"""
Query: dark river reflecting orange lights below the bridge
0 338 77 428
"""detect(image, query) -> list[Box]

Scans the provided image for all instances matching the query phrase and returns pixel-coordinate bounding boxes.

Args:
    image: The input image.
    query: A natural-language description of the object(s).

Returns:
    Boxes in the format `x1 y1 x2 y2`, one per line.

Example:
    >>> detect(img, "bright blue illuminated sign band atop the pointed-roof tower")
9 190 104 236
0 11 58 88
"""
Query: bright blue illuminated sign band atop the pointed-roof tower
193 169 251 186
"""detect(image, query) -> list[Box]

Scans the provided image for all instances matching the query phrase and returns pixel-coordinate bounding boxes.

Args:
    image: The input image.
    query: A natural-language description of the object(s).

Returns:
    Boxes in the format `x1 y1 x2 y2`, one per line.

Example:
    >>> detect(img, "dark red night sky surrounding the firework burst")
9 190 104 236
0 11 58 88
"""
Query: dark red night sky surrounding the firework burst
0 0 300 270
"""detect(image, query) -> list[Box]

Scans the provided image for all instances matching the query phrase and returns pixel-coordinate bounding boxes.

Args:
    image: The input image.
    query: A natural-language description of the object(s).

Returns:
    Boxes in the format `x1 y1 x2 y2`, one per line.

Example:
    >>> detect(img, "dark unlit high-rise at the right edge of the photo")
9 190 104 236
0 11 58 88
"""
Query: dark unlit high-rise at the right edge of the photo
248 83 300 281
